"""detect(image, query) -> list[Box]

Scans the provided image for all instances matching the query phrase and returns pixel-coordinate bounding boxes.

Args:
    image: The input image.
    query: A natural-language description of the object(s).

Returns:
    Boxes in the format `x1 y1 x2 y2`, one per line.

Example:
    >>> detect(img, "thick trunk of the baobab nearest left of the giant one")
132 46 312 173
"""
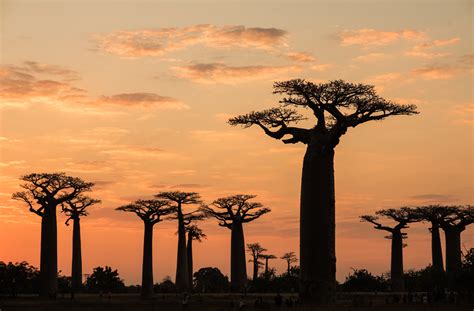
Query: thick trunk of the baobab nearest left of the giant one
230 220 247 292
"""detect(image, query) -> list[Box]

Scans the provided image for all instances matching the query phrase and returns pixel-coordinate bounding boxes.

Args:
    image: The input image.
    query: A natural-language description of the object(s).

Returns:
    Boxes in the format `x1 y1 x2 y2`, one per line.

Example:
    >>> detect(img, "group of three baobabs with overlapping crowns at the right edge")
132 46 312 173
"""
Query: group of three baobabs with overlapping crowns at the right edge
360 205 474 292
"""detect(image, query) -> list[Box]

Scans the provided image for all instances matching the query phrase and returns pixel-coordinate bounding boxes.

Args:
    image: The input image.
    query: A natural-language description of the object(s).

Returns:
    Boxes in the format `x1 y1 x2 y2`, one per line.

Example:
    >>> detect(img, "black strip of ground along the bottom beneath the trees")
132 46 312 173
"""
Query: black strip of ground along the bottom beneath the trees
0 294 474 311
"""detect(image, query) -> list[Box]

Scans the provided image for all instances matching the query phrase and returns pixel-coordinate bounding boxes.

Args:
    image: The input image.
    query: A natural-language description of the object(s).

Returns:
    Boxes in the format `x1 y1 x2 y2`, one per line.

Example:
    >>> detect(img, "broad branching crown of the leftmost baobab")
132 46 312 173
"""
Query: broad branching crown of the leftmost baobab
12 173 94 217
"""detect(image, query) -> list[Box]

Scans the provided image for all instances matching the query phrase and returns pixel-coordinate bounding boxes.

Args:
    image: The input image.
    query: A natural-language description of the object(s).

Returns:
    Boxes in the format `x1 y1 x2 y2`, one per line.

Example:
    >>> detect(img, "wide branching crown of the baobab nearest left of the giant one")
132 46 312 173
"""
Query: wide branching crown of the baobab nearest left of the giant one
201 194 270 229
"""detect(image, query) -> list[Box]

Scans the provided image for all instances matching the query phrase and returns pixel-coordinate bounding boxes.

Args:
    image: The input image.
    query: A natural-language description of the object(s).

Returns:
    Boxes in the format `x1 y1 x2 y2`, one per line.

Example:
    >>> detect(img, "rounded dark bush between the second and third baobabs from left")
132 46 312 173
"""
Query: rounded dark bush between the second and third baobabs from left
86 266 125 293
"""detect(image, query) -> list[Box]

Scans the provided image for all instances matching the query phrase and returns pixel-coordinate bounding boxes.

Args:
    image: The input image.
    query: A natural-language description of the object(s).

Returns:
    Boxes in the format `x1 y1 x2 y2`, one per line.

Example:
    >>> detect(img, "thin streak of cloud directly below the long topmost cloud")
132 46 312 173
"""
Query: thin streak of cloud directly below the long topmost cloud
174 63 301 84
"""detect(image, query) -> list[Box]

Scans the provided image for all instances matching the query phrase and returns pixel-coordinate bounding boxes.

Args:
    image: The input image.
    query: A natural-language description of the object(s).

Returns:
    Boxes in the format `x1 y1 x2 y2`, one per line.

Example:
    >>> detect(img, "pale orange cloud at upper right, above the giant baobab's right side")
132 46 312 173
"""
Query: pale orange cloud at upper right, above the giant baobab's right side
337 28 426 47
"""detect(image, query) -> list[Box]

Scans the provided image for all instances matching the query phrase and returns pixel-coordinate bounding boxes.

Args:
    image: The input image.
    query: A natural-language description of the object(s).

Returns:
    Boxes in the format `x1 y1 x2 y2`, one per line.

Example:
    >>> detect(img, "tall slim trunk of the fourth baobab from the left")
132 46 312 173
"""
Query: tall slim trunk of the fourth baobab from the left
176 204 189 293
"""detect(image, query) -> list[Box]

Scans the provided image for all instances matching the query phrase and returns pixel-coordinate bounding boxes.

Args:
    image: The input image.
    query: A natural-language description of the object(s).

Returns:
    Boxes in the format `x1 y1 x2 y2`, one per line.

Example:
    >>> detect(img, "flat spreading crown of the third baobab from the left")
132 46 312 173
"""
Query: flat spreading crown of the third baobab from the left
116 199 176 225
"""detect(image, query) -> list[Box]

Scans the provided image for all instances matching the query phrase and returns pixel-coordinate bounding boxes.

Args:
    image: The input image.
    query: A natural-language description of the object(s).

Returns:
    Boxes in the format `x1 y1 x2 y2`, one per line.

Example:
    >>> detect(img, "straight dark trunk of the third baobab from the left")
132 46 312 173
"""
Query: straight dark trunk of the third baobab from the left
141 221 153 298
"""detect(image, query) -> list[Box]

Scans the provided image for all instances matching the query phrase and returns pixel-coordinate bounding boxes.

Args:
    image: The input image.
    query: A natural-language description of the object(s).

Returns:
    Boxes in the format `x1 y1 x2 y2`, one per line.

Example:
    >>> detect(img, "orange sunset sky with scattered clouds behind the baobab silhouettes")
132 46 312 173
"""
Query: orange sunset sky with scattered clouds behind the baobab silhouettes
0 0 474 284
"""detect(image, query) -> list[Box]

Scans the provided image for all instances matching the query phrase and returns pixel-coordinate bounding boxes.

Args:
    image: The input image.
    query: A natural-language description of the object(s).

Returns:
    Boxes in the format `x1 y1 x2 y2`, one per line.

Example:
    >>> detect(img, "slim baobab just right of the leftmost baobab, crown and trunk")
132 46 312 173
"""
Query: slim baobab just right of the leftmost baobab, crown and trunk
61 195 100 293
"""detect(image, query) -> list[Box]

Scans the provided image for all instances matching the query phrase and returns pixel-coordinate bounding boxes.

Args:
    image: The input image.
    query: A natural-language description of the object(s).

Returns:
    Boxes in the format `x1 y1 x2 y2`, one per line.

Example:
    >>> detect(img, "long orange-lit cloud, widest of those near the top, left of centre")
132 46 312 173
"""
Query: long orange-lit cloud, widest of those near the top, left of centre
97 24 286 58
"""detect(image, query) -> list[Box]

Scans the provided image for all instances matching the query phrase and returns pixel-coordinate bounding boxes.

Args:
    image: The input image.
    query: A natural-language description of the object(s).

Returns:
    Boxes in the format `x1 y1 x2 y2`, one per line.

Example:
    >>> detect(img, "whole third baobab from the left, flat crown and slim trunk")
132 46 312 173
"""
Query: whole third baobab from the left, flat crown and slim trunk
116 199 175 298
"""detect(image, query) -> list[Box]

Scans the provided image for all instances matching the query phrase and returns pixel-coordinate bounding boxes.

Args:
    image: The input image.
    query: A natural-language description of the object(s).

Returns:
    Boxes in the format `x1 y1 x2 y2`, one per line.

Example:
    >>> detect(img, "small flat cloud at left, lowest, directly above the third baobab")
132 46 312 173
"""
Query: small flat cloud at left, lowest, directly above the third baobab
98 93 189 110
